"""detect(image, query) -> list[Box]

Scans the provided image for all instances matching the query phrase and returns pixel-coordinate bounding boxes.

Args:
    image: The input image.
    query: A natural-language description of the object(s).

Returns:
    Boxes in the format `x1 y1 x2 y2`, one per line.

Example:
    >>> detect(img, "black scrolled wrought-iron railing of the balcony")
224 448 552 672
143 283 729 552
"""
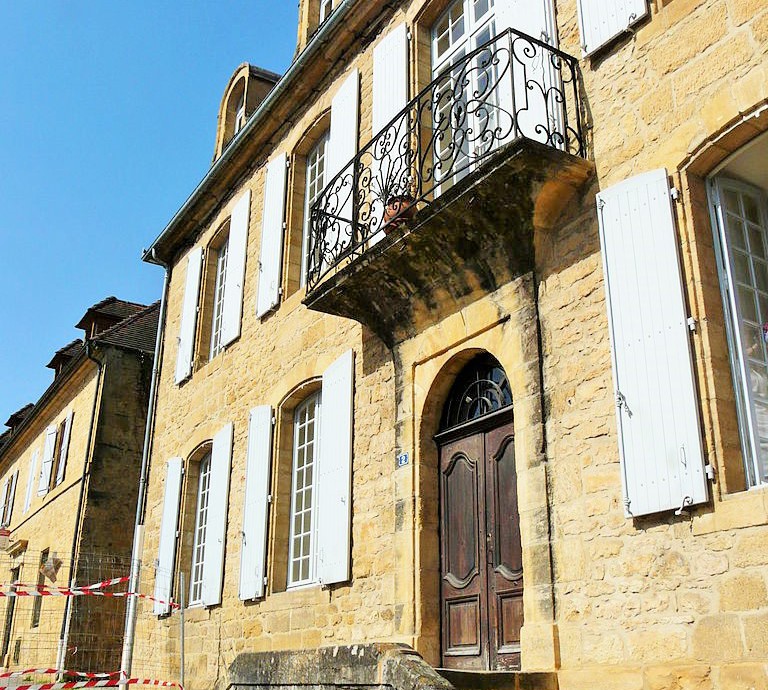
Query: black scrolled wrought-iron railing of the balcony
307 29 586 289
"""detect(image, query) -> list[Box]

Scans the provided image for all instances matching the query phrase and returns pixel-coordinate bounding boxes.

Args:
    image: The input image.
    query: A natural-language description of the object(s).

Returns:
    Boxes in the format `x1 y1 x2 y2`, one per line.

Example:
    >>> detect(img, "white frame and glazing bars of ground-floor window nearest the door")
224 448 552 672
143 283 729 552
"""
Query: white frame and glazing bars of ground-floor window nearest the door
286 391 322 589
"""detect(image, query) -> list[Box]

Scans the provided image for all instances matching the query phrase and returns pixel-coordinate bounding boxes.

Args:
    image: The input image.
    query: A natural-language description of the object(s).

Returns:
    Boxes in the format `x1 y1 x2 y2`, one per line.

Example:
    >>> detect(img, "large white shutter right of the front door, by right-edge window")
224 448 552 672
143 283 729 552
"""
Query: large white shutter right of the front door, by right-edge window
597 169 707 516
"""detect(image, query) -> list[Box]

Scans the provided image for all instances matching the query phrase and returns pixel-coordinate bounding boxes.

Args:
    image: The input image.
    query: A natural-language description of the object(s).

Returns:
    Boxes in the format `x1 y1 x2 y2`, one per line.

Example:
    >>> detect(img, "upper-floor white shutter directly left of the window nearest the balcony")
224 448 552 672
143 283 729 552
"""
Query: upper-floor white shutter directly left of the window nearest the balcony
256 153 288 317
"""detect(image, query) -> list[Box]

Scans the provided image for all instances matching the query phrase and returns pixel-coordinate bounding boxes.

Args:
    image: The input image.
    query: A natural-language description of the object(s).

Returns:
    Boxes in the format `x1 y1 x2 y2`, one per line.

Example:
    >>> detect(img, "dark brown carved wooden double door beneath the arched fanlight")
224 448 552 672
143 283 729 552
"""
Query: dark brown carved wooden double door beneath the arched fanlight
435 410 523 670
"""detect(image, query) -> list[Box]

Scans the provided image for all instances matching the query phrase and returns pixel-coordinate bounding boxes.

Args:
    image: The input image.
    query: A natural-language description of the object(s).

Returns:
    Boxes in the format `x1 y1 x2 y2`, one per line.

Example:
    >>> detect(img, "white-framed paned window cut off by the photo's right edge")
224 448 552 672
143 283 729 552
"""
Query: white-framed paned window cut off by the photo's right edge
710 167 768 487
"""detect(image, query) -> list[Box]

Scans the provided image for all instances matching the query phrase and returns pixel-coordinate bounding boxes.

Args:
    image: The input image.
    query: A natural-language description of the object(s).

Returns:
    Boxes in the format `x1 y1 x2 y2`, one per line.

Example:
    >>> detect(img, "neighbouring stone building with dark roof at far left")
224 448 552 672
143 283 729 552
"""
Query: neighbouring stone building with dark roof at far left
0 297 159 680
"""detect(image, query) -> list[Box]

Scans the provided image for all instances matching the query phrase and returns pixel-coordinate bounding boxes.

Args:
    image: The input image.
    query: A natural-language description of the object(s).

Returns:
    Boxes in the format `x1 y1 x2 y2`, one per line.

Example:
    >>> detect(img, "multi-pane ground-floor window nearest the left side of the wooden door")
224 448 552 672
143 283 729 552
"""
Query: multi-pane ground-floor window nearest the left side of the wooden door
288 393 320 587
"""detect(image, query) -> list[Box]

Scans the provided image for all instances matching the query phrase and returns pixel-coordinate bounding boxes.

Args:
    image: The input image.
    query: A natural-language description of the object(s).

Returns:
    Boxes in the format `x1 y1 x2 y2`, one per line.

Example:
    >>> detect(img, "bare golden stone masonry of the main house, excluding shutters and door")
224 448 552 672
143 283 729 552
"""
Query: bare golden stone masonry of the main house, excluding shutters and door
137 0 768 690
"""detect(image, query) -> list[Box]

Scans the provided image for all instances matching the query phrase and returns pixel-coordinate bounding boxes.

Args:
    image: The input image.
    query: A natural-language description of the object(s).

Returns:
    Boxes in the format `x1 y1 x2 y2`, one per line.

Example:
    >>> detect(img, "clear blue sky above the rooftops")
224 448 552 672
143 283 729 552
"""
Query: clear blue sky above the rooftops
0 0 298 420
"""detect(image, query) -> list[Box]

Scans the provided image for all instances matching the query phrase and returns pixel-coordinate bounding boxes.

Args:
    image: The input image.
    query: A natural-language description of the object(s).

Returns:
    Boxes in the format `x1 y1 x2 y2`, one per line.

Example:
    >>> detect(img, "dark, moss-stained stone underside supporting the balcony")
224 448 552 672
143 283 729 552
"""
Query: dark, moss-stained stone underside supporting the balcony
304 138 594 347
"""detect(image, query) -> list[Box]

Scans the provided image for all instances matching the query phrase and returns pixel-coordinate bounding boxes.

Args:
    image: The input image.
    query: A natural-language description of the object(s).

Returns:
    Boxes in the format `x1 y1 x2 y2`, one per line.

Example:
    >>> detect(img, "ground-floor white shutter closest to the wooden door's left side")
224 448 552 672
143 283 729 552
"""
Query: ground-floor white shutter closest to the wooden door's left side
317 350 355 585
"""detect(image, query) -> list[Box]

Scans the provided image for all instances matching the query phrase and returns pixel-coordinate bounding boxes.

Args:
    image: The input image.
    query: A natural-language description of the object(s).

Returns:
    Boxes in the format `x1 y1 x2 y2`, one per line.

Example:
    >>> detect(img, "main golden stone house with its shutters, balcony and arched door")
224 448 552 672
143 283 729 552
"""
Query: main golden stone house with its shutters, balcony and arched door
136 0 768 690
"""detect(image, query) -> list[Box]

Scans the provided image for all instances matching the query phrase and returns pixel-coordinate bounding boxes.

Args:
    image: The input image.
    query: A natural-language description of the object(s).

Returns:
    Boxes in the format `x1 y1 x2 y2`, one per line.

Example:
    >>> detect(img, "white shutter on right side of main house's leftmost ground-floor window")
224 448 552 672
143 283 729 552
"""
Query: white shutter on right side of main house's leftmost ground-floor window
202 422 232 606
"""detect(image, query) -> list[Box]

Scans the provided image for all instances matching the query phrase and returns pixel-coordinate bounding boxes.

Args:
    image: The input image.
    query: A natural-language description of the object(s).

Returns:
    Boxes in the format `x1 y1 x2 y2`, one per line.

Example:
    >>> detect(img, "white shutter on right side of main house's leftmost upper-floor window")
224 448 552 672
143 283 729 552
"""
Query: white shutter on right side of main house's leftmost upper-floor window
221 189 251 346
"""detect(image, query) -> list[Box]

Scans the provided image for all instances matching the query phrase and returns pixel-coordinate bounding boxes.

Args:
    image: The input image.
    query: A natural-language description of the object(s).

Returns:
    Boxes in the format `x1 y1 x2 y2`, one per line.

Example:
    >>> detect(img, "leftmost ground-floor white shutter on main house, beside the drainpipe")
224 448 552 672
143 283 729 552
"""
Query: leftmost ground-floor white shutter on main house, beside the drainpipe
153 458 184 616
